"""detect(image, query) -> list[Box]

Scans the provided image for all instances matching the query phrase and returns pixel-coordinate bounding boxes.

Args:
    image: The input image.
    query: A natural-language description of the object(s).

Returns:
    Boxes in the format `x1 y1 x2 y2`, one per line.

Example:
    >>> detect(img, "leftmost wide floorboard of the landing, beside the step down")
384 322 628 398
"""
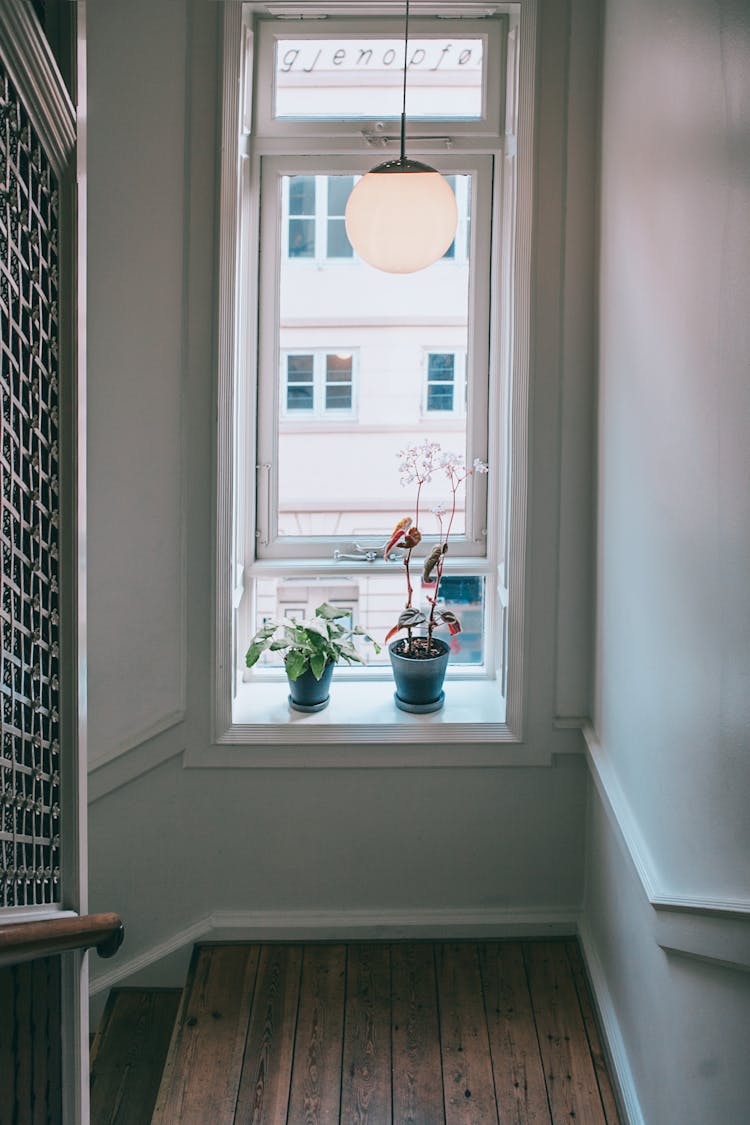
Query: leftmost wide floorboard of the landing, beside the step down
152 945 259 1125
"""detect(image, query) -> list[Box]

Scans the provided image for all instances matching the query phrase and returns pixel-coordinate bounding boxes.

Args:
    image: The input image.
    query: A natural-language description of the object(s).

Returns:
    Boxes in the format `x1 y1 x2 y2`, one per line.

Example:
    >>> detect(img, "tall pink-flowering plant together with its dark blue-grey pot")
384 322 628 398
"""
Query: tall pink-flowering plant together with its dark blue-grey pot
385 441 487 713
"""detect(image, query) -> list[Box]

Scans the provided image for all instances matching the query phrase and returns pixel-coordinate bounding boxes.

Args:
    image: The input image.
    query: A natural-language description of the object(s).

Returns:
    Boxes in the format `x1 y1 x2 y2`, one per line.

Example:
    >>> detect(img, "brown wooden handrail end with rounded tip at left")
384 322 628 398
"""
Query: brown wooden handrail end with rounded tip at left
0 914 125 968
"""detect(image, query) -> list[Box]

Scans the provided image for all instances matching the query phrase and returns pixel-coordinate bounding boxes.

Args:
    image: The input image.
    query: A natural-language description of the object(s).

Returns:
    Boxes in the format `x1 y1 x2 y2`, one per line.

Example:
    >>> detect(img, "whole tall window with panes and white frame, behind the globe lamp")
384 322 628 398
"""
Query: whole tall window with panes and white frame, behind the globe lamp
217 0 535 741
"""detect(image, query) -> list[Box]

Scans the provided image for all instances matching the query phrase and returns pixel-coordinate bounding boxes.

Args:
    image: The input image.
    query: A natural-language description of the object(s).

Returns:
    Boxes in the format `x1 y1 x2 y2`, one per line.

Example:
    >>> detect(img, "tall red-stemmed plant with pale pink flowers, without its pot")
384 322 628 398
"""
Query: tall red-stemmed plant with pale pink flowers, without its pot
383 441 487 657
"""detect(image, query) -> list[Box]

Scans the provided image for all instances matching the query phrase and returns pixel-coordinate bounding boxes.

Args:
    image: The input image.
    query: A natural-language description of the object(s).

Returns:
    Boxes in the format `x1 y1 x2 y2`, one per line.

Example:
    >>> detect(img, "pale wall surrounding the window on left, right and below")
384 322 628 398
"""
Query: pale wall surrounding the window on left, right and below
83 0 593 999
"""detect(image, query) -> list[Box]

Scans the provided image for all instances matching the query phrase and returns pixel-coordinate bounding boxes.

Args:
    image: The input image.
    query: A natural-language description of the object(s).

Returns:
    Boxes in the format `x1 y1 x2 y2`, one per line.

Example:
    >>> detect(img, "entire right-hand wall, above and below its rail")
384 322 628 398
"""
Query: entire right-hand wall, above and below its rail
586 0 750 1111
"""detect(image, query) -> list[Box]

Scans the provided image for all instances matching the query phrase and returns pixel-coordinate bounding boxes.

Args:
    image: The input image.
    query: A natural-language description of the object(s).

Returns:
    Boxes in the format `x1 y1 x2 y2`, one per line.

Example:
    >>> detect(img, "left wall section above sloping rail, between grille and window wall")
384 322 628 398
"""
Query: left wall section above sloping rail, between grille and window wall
88 0 187 761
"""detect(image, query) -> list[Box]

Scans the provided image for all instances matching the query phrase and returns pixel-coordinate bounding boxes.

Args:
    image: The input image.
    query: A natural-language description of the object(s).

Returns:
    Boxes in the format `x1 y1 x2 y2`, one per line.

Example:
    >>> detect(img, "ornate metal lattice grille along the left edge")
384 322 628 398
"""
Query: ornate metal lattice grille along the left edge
0 59 61 907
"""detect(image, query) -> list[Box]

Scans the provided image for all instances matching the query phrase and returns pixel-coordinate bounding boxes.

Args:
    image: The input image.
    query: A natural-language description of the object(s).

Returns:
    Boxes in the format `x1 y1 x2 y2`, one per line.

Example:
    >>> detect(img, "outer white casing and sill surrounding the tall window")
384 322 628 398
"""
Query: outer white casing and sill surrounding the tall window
214 0 537 751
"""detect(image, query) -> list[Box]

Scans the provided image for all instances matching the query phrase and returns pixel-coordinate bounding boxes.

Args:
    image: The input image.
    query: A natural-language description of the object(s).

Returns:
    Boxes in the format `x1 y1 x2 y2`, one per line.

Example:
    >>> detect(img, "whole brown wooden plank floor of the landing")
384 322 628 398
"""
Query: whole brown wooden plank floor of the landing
148 941 618 1125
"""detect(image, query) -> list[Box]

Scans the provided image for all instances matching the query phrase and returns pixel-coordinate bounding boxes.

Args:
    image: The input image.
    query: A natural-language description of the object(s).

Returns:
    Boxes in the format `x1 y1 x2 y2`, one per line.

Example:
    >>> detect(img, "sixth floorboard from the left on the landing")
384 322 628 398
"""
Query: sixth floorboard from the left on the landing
436 943 498 1125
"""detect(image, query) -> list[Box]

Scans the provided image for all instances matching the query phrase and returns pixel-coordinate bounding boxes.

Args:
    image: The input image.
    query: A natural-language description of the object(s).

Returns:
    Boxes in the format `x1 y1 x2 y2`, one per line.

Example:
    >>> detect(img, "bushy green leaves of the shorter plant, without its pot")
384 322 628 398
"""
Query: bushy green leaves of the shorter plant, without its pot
245 602 380 680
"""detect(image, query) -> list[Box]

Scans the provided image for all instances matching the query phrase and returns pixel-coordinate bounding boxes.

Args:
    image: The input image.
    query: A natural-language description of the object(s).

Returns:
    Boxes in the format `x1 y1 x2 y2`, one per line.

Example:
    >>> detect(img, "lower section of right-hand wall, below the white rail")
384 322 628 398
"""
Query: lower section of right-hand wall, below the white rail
581 788 750 1125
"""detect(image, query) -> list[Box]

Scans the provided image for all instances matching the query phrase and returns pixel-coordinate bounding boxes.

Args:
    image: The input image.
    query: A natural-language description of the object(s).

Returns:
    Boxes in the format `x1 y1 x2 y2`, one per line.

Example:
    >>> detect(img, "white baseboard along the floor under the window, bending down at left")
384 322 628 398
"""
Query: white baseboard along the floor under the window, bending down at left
89 906 578 996
